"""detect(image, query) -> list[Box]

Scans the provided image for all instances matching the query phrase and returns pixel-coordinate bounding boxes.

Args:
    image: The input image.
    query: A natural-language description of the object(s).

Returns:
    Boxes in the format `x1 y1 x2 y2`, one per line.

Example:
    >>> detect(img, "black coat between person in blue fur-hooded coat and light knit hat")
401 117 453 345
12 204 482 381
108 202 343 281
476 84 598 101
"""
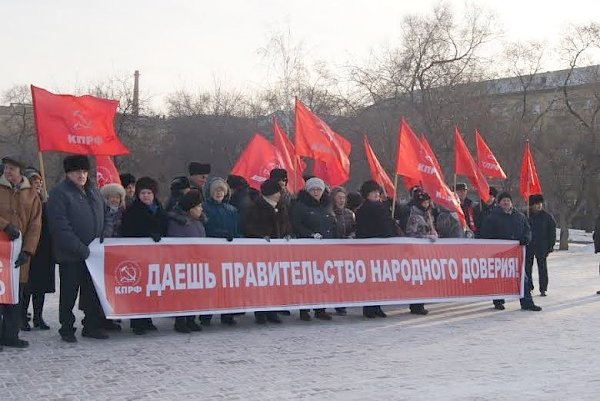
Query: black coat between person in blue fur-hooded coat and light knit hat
243 196 292 238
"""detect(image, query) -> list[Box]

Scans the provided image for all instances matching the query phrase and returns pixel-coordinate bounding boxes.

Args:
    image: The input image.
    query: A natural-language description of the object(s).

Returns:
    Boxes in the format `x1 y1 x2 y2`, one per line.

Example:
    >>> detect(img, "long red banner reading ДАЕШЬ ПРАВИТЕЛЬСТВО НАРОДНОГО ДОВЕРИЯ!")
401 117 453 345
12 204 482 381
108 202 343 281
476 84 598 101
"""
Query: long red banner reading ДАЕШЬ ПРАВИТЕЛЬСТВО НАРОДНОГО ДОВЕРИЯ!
86 238 524 318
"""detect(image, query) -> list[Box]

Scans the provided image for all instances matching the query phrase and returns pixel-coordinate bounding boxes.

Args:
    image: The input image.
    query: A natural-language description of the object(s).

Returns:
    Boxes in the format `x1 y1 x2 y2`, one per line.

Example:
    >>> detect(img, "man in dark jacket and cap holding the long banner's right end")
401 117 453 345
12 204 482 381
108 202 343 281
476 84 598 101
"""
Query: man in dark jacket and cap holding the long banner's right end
480 192 542 312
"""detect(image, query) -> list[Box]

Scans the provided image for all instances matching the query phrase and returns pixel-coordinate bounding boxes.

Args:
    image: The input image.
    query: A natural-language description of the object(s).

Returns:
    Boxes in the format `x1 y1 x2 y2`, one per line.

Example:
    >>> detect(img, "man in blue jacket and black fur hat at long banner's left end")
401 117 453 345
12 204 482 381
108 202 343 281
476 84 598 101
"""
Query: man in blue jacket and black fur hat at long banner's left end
47 155 108 343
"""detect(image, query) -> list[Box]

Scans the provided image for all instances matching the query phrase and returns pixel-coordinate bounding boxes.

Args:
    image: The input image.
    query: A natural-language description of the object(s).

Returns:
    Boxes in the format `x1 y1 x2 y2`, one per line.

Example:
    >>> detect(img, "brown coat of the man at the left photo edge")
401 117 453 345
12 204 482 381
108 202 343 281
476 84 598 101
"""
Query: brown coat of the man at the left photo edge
0 176 42 283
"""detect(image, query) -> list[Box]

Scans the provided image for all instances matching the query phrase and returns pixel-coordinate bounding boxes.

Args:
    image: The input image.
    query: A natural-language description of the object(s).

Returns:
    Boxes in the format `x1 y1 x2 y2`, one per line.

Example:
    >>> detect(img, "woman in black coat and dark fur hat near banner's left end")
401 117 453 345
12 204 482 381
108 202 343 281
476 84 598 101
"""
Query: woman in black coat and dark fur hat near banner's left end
121 177 168 335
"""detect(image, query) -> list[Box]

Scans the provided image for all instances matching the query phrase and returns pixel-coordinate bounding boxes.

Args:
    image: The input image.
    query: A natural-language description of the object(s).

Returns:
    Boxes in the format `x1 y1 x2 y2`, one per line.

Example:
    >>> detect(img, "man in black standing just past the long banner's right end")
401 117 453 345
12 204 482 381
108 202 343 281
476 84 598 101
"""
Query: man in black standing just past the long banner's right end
525 195 556 297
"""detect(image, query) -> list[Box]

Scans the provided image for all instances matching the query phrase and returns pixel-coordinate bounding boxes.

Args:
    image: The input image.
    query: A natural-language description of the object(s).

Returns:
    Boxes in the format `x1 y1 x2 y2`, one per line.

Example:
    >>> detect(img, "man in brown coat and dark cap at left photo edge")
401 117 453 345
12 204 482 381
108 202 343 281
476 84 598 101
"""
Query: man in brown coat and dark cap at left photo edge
0 156 42 348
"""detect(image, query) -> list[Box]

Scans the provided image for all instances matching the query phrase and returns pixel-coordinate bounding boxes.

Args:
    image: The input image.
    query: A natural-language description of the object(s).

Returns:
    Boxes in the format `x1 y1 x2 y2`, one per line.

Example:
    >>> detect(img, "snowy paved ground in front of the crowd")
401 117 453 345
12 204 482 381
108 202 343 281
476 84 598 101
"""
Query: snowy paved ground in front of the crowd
0 242 600 401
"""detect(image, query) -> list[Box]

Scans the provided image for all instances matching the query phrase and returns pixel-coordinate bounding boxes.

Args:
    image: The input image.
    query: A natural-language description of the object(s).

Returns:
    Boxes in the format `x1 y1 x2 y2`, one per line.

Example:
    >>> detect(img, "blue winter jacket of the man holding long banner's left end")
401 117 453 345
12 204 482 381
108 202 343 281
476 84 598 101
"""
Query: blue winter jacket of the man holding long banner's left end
47 178 105 263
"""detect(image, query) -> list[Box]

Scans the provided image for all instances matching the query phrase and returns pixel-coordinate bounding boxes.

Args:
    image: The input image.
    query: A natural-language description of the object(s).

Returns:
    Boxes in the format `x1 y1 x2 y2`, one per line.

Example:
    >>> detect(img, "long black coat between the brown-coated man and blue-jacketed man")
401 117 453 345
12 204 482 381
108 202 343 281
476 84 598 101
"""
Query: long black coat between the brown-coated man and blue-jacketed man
27 203 56 294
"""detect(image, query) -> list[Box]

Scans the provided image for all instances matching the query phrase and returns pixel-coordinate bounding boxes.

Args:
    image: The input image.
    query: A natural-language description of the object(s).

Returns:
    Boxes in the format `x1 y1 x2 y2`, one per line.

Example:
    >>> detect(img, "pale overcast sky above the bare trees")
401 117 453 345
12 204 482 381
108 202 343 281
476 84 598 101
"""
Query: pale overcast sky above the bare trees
0 0 600 108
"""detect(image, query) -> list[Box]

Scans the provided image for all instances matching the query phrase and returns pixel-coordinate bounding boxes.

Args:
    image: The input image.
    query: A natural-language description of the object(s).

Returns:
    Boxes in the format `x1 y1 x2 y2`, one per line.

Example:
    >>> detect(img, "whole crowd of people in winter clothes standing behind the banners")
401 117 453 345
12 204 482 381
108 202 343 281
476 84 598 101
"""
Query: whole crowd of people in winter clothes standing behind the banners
0 155 556 348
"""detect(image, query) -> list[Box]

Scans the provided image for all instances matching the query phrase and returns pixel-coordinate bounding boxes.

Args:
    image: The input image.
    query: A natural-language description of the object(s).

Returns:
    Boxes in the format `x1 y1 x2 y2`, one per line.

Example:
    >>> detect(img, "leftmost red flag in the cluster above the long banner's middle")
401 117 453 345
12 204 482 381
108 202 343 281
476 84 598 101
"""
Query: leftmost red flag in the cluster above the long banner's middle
230 133 283 191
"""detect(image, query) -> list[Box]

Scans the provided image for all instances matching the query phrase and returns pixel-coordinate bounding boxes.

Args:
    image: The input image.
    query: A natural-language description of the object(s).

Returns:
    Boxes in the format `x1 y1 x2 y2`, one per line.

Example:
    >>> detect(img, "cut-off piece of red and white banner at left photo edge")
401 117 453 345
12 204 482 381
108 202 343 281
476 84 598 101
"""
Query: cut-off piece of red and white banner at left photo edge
0 232 21 304
